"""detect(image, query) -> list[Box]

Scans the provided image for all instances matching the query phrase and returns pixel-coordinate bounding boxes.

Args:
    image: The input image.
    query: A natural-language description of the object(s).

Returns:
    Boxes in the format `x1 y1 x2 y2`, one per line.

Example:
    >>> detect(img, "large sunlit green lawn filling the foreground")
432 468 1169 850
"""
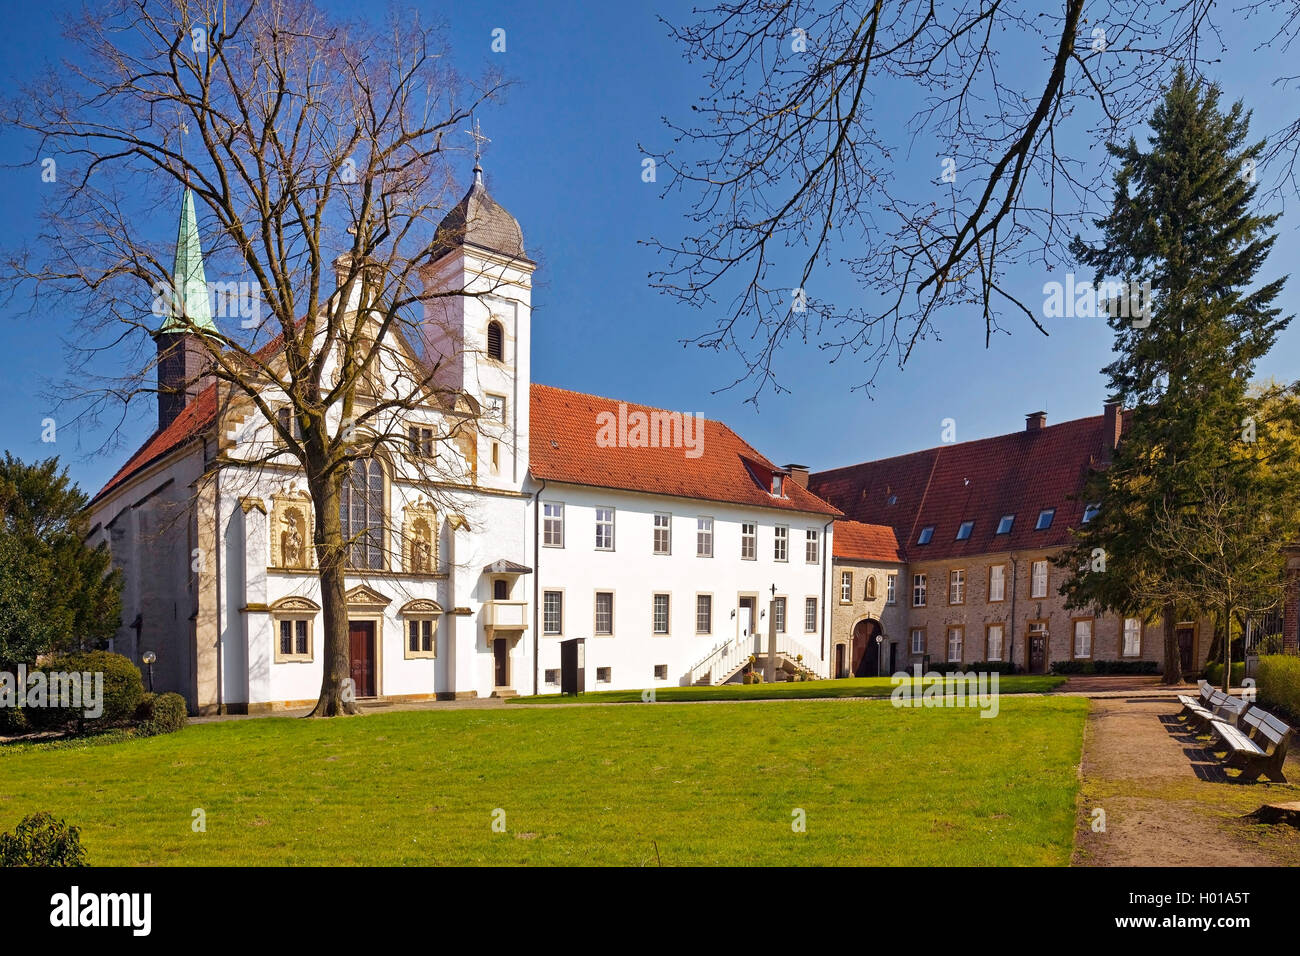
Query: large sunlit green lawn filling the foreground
0 697 1088 865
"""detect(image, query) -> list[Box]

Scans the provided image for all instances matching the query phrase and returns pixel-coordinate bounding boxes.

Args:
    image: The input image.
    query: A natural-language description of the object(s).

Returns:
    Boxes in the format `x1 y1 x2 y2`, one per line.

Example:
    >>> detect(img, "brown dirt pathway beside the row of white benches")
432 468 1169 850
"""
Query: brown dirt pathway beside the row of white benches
1074 688 1300 866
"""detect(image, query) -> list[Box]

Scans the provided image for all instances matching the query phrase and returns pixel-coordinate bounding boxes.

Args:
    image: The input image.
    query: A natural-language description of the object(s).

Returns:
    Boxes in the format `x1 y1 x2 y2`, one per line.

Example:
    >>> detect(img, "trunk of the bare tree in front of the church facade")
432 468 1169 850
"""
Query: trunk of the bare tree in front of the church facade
308 470 360 717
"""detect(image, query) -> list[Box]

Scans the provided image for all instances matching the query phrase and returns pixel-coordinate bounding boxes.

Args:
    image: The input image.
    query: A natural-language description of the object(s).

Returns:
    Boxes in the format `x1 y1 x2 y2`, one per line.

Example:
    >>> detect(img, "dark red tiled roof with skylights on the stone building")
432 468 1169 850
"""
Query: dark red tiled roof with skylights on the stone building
809 415 1128 561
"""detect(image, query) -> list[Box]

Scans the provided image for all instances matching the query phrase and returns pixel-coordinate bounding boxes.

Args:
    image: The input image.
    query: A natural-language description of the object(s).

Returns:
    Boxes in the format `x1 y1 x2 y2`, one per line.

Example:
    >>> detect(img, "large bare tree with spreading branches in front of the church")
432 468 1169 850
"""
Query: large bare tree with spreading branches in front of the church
5 0 514 715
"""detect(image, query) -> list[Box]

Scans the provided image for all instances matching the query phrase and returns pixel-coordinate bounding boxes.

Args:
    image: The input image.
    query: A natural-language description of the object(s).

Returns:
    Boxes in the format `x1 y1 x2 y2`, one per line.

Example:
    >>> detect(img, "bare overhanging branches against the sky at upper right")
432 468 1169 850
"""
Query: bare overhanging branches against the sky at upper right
642 0 1300 401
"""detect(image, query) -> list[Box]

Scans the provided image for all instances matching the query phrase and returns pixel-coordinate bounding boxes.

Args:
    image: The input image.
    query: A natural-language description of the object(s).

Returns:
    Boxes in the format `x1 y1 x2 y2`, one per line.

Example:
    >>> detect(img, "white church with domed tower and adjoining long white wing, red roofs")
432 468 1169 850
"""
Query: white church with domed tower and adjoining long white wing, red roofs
90 181 840 713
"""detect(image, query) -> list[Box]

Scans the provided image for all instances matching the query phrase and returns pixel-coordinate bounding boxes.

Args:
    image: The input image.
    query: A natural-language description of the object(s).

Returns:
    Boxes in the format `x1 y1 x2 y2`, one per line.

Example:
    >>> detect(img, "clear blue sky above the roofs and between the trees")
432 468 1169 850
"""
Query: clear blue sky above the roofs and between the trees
0 0 1300 502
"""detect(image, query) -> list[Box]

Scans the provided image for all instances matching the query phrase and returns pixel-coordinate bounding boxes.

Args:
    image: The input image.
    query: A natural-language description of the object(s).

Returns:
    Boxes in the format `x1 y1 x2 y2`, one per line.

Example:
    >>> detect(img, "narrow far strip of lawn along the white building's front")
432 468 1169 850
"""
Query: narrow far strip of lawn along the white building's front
510 674 1067 704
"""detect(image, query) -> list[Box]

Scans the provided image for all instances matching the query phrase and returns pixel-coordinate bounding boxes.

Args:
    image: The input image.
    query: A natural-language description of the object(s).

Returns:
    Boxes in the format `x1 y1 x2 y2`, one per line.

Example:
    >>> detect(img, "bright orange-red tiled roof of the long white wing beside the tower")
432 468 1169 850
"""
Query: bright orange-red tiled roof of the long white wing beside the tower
528 385 839 515
